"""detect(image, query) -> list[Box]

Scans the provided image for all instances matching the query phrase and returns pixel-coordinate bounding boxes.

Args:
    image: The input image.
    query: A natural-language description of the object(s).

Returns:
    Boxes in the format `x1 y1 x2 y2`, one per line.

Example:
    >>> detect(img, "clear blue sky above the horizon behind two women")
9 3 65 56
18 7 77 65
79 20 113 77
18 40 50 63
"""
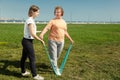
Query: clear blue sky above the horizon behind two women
0 0 120 21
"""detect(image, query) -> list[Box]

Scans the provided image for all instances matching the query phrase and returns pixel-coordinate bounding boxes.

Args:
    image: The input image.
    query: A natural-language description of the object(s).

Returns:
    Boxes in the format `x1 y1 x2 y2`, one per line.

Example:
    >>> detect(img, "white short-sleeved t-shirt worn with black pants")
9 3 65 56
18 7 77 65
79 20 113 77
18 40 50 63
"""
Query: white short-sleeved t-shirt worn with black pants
24 17 37 39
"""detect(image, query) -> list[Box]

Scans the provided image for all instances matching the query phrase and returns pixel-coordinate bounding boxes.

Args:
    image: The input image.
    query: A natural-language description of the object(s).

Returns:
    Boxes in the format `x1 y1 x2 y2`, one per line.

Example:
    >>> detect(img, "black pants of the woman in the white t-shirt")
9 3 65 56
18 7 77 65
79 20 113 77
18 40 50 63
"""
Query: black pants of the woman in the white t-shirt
21 39 37 77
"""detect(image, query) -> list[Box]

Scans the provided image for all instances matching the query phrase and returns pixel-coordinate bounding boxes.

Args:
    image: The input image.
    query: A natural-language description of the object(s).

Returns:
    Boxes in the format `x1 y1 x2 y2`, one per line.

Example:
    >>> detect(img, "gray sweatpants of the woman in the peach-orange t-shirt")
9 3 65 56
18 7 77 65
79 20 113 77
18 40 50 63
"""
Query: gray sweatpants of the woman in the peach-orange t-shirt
48 40 64 67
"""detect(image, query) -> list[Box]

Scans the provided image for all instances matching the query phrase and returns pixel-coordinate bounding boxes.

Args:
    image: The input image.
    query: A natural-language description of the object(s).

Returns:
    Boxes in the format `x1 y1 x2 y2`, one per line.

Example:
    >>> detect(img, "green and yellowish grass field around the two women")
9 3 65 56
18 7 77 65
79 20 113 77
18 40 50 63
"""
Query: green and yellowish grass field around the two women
0 24 120 80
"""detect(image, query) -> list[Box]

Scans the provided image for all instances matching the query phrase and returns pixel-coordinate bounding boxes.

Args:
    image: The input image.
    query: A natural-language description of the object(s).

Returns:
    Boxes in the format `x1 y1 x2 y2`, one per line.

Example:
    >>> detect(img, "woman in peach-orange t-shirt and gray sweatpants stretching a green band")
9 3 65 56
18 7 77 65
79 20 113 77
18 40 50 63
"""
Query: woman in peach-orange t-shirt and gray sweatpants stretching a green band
40 6 74 75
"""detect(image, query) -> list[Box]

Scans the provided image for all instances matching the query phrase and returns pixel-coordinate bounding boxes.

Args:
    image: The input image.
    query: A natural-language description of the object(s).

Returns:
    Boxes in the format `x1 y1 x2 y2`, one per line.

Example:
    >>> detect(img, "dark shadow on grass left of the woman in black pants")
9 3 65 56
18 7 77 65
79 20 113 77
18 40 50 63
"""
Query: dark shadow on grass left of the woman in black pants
0 60 21 78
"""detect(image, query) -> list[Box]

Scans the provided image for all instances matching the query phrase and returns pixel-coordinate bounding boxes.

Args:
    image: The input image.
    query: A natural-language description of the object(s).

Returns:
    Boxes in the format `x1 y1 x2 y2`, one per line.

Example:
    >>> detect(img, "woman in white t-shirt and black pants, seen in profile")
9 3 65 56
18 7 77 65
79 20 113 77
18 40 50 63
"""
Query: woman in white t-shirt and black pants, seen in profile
21 5 44 80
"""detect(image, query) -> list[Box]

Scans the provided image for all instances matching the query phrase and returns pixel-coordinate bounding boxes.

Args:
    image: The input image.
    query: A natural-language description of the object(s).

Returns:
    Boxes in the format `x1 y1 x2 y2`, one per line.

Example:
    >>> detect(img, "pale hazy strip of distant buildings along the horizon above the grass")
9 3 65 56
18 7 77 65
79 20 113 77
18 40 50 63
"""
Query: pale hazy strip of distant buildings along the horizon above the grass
0 18 120 24
